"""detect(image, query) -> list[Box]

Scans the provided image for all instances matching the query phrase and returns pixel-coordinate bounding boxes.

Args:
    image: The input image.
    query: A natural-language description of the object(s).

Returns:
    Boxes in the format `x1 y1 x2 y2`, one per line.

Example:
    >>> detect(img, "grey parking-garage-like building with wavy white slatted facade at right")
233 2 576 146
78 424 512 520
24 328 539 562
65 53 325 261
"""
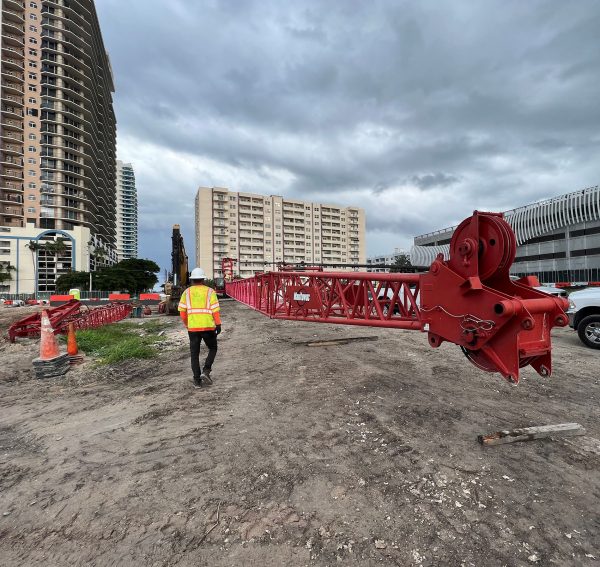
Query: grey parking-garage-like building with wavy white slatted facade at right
410 186 600 286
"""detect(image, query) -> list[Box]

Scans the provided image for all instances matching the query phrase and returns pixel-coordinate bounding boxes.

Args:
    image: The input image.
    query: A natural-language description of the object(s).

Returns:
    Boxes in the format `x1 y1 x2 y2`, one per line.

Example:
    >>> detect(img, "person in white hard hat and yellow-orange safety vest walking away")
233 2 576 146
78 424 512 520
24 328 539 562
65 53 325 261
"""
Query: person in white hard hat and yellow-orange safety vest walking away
179 268 221 388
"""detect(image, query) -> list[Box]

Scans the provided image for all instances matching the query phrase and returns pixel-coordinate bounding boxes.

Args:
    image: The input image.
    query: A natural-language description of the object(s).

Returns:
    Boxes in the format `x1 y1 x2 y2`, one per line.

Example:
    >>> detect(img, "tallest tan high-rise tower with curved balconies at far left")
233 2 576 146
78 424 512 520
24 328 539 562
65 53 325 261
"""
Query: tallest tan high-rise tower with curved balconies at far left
0 0 116 287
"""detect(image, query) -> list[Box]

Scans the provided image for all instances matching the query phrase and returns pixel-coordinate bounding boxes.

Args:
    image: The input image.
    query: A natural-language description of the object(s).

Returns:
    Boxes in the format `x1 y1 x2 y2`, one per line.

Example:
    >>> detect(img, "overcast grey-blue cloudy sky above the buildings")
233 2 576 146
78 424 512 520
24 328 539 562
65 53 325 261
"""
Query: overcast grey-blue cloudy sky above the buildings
96 0 600 267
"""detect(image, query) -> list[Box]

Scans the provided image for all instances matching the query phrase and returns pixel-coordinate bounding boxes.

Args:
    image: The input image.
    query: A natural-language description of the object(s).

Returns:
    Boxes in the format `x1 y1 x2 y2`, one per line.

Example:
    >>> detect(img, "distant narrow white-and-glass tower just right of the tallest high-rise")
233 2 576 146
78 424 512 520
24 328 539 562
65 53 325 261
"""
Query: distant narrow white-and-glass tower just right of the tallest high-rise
117 160 138 261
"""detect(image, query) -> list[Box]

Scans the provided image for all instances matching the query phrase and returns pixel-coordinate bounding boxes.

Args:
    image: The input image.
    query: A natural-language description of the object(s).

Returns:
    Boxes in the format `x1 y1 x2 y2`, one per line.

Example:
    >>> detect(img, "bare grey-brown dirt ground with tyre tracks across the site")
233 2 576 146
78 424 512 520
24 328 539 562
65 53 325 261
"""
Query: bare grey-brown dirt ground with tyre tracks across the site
0 302 600 567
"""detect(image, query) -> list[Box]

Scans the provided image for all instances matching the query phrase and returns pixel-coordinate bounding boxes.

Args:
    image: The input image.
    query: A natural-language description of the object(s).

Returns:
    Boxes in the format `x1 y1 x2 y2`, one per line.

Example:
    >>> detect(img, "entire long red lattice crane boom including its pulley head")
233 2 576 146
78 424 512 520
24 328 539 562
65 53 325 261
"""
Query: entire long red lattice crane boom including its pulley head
226 211 568 383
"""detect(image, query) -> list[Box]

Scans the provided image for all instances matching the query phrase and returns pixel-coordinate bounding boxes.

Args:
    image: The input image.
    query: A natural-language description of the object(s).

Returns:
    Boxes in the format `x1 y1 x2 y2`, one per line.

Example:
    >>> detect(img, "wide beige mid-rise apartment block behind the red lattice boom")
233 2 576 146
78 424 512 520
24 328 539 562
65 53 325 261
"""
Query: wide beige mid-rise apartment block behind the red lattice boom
195 187 366 278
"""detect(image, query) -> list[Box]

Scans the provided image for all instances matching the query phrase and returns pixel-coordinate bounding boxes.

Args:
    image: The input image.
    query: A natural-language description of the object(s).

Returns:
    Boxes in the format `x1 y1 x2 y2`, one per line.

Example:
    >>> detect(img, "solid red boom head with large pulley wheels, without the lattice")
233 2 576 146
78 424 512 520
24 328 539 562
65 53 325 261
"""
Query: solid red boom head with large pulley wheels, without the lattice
420 211 568 384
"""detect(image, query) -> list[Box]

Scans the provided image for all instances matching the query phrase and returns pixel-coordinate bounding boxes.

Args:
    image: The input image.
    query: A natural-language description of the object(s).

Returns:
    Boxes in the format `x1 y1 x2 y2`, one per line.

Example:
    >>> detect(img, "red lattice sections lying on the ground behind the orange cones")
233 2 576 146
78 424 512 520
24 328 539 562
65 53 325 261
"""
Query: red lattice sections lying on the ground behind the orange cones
8 299 133 343
